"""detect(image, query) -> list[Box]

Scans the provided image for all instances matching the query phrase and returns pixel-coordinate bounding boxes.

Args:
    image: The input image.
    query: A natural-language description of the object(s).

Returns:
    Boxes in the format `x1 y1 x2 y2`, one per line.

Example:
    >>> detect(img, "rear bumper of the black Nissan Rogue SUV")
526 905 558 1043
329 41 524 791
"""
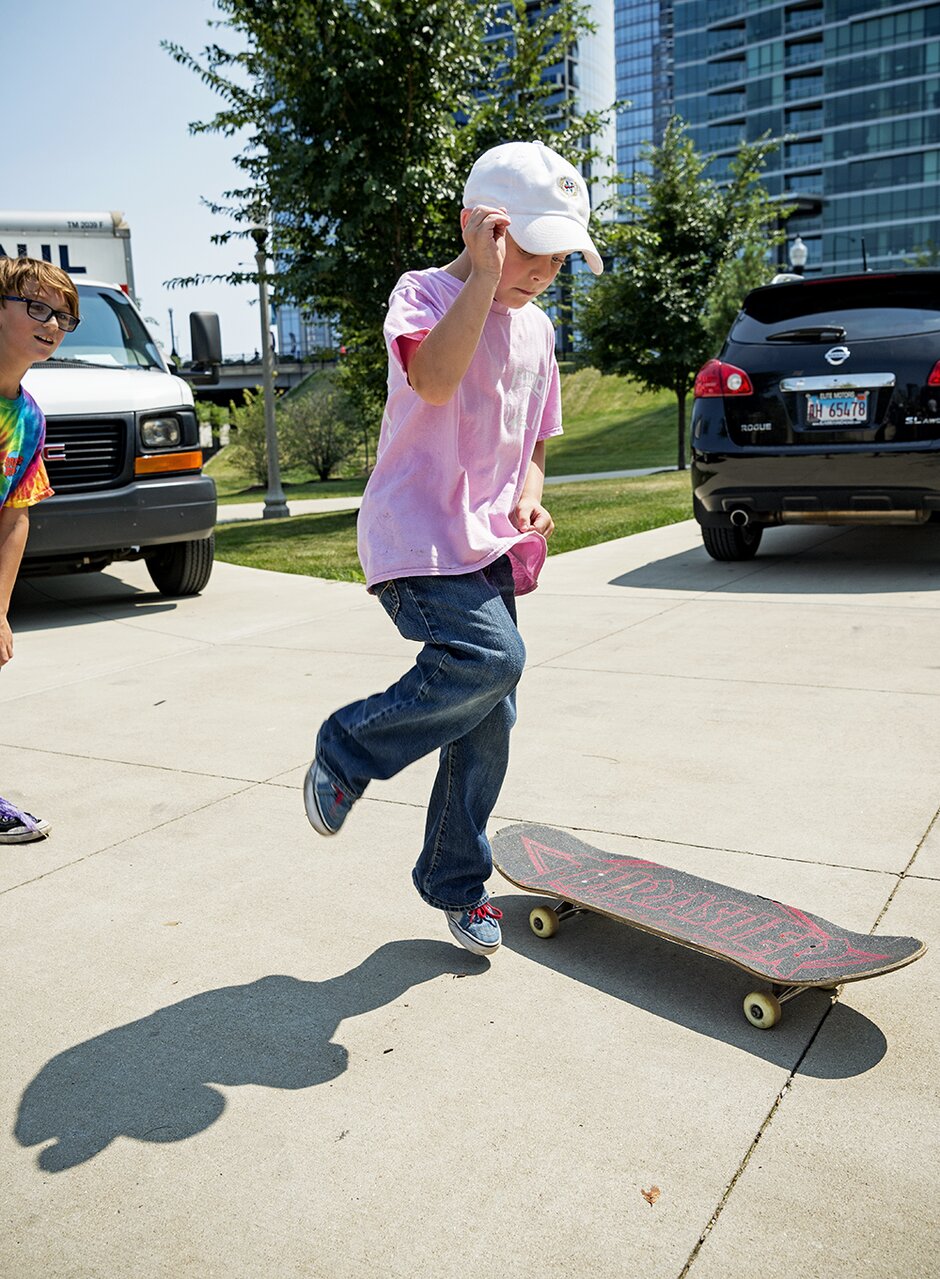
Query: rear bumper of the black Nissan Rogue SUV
691 450 940 528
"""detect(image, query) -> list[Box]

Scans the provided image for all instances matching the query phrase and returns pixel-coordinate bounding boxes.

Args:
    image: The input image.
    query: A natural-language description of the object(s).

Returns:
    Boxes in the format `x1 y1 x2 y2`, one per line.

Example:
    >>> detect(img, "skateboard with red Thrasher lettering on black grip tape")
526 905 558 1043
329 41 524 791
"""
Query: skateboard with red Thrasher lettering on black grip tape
492 825 927 1030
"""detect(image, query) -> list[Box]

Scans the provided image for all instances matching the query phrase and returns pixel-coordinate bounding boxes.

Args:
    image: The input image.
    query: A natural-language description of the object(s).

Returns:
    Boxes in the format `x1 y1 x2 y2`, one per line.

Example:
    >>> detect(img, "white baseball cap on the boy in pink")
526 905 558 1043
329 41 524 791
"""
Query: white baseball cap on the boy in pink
463 142 604 275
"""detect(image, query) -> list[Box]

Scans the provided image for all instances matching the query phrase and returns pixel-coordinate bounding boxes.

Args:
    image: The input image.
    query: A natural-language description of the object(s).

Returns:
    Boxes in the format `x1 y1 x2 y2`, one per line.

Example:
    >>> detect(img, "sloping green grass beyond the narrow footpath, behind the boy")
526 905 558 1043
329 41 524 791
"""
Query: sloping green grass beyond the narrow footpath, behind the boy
206 368 677 504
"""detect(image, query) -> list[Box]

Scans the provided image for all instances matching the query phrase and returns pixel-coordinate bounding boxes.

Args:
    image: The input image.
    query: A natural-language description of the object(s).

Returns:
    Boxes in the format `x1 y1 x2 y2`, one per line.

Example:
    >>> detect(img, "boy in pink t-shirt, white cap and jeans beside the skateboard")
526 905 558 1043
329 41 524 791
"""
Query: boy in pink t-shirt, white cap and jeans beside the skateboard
304 142 604 954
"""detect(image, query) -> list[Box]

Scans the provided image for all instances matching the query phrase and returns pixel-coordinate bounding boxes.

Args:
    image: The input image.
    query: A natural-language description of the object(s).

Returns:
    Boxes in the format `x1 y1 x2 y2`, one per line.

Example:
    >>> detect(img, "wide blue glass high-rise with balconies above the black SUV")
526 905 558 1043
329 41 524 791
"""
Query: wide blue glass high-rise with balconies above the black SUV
675 0 940 272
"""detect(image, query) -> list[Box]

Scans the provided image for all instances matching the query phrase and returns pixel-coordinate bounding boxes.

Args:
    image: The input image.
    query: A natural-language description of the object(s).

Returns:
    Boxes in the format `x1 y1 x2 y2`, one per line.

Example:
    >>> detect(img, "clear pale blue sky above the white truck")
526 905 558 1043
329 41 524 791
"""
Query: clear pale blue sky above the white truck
0 0 261 358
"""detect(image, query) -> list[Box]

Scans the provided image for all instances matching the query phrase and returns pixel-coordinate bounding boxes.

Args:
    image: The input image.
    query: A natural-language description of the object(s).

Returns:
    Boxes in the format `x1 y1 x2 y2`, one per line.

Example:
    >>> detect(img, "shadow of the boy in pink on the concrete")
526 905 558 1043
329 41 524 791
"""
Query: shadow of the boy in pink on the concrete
15 941 489 1173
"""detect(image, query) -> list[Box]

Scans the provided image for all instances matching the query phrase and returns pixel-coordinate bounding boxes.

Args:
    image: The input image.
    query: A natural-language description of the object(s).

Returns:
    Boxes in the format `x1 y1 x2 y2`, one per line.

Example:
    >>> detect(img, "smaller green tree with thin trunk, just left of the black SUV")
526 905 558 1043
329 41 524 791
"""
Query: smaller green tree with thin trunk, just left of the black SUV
578 116 789 469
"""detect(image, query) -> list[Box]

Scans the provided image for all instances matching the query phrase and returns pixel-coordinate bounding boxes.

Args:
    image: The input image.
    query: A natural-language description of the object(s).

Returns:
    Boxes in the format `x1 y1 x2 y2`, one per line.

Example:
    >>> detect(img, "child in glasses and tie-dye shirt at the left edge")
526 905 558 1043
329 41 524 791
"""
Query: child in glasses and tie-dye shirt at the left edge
0 257 78 844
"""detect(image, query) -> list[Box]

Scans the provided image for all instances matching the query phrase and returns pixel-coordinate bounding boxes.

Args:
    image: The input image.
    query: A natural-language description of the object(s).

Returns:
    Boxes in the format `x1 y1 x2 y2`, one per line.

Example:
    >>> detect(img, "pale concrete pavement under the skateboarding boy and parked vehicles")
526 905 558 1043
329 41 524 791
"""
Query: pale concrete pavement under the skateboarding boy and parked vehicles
0 523 940 1279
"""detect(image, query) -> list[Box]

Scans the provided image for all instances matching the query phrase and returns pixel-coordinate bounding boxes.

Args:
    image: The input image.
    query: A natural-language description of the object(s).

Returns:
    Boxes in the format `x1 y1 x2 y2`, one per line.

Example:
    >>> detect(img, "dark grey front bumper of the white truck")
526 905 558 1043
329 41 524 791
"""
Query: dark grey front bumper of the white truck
23 475 216 569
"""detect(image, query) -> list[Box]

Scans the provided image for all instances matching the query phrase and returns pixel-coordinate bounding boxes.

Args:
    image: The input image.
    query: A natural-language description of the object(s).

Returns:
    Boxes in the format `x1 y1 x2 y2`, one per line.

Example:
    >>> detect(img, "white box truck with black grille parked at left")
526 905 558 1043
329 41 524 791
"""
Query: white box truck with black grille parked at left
0 212 221 595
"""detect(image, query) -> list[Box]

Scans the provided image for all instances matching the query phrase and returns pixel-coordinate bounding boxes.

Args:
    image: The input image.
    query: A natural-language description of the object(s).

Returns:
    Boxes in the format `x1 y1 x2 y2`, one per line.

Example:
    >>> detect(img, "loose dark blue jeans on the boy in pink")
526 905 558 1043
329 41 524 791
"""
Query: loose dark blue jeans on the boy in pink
317 555 526 911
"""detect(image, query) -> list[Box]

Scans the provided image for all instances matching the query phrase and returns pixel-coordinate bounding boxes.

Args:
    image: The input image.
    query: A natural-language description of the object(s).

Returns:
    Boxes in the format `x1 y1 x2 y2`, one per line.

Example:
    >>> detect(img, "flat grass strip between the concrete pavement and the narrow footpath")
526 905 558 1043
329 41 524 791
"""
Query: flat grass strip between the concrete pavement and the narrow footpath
215 468 692 582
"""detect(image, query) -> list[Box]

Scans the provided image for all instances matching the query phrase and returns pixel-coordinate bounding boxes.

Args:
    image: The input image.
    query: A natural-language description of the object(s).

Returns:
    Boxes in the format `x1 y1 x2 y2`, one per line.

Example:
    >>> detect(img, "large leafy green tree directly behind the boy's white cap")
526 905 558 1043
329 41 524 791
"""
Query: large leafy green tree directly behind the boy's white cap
165 0 613 445
